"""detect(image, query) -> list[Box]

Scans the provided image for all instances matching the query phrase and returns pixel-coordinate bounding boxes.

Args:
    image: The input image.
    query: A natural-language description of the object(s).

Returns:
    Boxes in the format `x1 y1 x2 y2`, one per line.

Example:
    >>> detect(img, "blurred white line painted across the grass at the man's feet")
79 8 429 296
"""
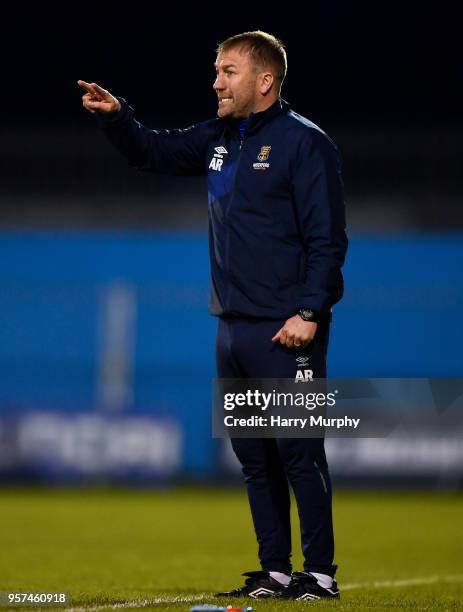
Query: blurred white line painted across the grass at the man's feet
64 574 463 612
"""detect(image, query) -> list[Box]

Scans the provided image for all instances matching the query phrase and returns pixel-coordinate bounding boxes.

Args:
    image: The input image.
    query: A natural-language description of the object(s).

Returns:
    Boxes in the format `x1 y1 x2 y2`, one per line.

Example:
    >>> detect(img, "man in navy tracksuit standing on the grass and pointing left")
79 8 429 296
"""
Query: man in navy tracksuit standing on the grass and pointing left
79 31 347 600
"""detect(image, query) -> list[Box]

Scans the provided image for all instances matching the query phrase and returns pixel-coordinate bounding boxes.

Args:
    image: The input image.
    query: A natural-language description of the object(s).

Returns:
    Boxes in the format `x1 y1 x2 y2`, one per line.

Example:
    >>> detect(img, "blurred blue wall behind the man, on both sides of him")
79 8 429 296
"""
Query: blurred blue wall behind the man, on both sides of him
0 233 463 477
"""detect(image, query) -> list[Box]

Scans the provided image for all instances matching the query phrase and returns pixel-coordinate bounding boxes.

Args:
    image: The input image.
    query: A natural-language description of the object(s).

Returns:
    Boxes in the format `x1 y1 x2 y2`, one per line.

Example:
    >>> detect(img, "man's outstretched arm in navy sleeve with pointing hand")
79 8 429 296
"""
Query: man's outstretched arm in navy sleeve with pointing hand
79 81 207 175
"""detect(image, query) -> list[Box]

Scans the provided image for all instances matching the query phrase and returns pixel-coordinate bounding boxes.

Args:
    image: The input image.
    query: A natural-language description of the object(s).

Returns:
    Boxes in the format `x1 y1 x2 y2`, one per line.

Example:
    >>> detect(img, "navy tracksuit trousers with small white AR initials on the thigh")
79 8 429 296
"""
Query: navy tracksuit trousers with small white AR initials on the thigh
216 317 336 576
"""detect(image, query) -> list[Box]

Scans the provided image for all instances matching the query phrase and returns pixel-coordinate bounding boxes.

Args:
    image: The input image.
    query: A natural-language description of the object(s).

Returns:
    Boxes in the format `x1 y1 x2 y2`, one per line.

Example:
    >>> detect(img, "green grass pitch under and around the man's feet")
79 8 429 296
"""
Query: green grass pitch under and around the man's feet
0 488 463 612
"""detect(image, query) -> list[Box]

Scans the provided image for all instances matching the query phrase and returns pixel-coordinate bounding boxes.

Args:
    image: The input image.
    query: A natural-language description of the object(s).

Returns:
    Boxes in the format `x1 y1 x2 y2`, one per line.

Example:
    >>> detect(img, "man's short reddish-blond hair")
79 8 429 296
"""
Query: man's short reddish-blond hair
216 30 288 89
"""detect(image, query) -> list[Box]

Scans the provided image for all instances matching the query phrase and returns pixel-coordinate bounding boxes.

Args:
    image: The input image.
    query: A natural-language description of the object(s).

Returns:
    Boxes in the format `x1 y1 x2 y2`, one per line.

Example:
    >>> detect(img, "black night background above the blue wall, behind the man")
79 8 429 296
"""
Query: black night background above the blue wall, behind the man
0 0 463 231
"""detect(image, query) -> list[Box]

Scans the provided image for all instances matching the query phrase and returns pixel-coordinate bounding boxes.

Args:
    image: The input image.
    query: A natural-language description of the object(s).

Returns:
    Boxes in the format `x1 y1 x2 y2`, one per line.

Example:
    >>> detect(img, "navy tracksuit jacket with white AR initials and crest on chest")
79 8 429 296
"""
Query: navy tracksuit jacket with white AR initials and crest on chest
98 98 347 319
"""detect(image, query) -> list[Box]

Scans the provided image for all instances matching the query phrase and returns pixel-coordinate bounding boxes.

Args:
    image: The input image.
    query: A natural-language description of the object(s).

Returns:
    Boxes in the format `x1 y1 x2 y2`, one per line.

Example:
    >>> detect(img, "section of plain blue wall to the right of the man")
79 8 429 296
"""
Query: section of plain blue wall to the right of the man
330 234 463 377
